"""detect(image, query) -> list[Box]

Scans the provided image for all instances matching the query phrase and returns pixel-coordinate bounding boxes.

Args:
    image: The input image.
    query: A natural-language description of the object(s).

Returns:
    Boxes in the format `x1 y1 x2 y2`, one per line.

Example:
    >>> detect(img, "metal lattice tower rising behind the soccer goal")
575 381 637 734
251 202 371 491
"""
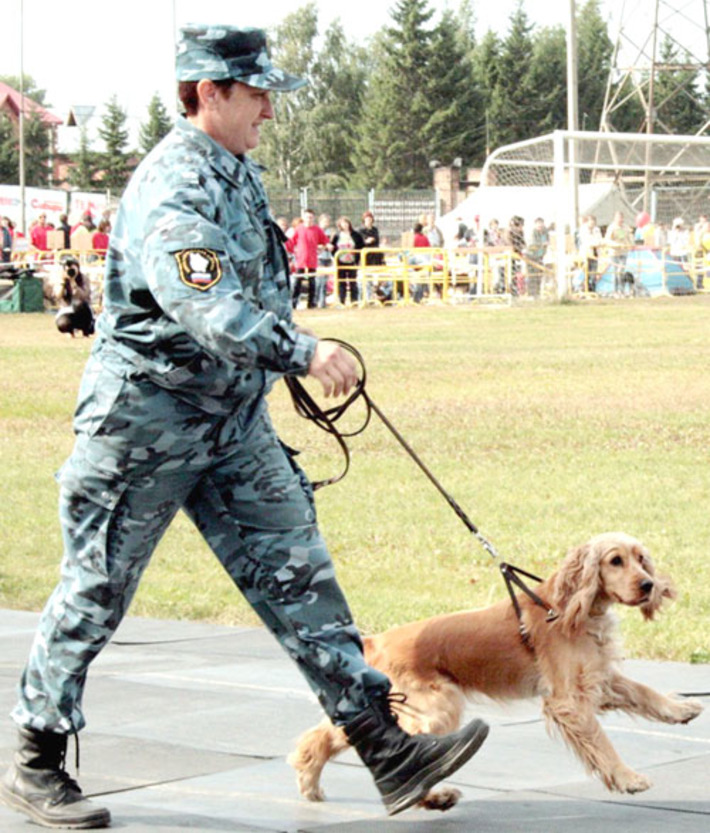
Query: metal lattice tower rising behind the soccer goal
600 0 710 135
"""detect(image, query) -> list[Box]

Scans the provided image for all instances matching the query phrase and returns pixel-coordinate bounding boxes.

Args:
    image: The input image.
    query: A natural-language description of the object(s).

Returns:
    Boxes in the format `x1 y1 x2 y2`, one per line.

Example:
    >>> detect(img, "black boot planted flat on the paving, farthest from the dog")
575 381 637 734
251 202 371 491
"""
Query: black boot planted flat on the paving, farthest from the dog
0 729 111 830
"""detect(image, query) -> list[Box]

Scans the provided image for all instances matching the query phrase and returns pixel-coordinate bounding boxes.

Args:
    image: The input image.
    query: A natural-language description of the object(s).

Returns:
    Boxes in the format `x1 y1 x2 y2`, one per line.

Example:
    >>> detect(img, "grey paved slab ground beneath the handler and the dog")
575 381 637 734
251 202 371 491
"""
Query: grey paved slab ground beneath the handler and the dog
0 610 710 833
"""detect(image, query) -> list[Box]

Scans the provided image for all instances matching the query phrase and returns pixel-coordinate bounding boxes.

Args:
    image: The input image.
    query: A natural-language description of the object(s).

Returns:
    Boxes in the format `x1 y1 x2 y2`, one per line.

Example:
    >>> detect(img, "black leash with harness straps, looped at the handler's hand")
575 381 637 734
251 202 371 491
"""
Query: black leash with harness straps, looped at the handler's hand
285 338 559 636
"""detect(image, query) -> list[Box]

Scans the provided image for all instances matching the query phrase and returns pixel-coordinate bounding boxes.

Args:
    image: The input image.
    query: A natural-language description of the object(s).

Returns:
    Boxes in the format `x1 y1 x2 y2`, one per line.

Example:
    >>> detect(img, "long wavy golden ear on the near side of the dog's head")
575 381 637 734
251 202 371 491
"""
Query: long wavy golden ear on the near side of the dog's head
552 543 600 635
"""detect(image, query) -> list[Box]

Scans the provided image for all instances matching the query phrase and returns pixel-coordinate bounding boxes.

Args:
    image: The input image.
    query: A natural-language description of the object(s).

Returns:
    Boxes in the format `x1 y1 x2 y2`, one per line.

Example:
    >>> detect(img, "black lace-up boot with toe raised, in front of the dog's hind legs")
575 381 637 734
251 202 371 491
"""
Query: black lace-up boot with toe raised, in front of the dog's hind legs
344 698 488 816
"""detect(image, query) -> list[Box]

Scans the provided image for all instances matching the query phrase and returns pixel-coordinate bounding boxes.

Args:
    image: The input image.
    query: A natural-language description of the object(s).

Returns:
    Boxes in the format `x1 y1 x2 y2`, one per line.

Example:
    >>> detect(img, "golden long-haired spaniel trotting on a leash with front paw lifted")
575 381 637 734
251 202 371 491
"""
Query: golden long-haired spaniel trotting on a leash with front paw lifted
289 532 702 809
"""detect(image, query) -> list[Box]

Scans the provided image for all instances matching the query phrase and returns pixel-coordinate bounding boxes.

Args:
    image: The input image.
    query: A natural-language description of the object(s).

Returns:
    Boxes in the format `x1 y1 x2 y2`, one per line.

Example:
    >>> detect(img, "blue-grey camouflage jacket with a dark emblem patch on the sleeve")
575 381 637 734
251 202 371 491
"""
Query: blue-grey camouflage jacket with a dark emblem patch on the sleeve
93 118 316 414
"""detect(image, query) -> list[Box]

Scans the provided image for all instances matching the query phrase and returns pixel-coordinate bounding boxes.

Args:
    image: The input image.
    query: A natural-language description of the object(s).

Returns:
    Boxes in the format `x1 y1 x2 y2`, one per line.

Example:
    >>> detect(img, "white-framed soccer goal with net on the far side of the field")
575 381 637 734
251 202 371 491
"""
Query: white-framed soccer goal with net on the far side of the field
481 130 710 296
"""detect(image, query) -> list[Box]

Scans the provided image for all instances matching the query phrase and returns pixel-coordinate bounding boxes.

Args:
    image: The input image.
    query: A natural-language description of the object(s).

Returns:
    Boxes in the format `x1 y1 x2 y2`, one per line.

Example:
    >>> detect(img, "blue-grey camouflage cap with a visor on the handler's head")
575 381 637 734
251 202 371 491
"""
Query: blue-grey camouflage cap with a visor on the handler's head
176 25 306 91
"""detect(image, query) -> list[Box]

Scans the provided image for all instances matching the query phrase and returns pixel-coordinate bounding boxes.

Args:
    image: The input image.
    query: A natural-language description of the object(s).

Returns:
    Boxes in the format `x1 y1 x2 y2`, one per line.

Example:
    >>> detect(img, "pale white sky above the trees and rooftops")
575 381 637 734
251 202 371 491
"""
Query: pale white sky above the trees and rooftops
0 0 612 127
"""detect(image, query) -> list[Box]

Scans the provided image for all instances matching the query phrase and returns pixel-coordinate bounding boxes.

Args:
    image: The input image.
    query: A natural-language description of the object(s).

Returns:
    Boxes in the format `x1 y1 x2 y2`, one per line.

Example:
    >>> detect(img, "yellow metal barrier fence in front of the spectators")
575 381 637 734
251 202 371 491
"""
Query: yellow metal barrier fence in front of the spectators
12 246 710 311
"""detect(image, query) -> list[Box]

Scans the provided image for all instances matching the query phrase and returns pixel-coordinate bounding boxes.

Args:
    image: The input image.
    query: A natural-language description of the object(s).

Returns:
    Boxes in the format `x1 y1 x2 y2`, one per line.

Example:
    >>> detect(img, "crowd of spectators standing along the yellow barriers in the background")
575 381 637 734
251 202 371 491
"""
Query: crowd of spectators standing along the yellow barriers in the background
5 202 710 316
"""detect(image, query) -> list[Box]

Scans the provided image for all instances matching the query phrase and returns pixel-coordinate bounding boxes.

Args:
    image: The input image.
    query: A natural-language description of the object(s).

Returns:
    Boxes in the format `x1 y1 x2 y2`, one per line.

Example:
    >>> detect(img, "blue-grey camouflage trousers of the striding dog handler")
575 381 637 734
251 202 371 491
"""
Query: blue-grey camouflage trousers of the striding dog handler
13 362 389 733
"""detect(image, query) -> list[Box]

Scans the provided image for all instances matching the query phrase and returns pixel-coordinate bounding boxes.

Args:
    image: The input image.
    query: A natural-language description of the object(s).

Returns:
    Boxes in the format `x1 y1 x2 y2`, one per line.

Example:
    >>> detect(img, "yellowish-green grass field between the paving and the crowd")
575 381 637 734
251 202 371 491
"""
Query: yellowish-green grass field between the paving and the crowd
0 297 710 662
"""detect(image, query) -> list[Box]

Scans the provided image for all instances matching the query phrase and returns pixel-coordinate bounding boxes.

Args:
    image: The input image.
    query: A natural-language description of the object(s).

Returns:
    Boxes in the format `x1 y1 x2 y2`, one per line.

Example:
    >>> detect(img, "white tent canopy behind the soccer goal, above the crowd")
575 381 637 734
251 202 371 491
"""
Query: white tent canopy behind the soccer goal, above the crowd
438 182 634 245
